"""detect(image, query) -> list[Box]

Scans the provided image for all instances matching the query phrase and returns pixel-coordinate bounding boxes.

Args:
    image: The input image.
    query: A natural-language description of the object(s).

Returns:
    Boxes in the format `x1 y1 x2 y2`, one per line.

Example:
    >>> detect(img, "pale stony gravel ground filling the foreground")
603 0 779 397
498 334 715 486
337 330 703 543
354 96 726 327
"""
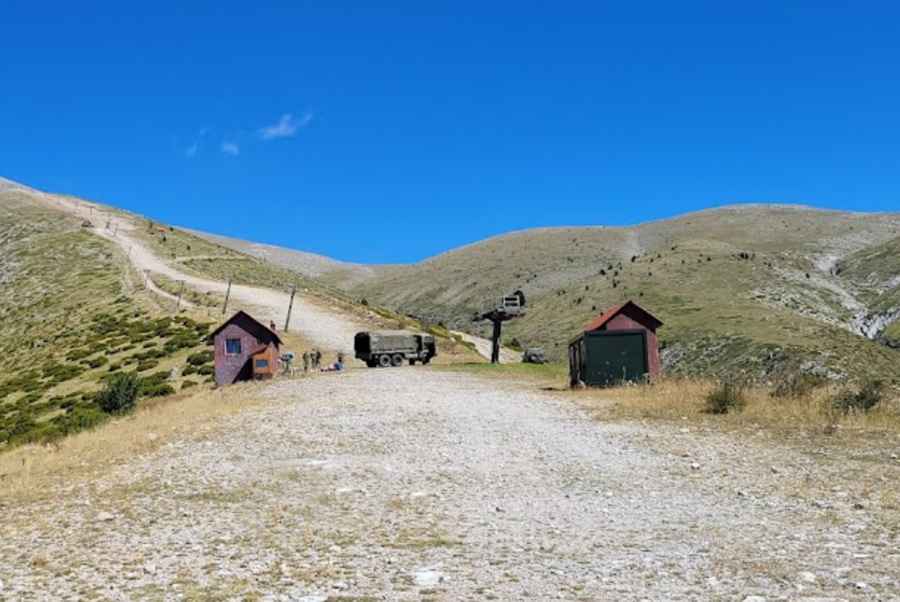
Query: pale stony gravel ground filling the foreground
0 368 900 601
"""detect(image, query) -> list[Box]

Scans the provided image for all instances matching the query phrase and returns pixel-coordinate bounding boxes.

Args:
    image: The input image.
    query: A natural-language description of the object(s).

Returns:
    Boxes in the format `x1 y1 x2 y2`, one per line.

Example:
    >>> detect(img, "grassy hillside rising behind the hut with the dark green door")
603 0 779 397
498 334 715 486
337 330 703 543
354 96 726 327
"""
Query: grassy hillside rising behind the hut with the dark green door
325 205 900 379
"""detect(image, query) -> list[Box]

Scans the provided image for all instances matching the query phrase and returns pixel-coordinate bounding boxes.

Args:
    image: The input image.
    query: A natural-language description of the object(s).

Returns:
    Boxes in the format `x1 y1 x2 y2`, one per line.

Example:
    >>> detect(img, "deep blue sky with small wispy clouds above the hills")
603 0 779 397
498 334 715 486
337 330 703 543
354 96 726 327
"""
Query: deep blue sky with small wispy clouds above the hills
0 1 900 262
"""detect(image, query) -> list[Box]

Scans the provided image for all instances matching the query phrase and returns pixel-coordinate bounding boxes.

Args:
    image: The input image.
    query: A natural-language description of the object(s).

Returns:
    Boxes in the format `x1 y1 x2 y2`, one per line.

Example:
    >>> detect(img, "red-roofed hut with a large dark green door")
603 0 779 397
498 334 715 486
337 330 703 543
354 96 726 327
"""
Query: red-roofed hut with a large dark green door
569 301 662 387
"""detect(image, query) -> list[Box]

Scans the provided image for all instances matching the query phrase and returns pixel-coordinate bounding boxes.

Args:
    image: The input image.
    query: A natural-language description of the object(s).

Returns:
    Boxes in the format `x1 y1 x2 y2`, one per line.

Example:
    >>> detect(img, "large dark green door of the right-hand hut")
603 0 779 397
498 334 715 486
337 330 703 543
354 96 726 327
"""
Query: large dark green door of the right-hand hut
584 331 647 386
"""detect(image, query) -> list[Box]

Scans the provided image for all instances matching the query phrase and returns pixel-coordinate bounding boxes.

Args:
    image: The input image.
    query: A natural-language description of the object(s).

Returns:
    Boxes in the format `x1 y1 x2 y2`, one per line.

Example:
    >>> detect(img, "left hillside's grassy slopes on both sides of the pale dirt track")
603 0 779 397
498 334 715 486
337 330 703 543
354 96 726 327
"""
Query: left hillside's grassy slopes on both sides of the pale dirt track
0 179 486 451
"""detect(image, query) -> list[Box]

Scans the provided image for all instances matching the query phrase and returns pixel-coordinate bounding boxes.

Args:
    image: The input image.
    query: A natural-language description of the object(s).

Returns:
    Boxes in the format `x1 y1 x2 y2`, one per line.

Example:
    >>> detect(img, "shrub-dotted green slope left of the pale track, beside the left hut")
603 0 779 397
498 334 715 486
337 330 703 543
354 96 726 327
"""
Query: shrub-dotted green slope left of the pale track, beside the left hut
0 187 217 450
